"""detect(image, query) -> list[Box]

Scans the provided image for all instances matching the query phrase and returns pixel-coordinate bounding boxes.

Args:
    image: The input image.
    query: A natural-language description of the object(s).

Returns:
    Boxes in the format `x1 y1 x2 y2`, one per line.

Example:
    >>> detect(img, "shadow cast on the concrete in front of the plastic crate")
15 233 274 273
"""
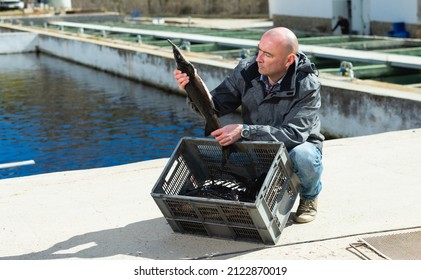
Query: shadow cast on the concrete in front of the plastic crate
0 217 290 260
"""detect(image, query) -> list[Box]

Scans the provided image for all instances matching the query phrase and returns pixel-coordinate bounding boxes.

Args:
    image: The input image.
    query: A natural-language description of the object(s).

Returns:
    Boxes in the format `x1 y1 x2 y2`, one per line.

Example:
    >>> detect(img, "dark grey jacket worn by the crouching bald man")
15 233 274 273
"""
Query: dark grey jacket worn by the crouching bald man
211 53 324 151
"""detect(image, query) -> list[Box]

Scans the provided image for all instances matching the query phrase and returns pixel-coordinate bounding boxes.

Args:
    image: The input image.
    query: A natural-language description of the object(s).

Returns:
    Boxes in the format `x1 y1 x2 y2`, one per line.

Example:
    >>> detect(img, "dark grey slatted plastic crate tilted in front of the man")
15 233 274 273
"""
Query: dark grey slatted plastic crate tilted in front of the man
151 137 300 244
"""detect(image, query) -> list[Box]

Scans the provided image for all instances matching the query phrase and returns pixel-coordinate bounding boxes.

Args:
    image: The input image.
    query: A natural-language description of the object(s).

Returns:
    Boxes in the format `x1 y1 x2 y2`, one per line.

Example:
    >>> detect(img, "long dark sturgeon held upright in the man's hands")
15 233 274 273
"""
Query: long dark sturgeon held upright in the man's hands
167 39 234 165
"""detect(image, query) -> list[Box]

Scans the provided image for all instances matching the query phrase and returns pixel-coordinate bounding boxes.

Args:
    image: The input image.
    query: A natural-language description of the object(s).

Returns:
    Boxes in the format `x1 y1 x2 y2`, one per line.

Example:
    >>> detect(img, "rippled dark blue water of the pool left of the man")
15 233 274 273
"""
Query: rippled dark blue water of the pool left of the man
0 54 239 178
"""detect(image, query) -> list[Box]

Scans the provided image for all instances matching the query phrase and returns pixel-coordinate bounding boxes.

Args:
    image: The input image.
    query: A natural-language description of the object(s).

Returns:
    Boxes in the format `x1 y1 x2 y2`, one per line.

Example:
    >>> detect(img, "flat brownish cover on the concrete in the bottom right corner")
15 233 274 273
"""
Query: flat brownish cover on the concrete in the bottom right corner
362 231 421 260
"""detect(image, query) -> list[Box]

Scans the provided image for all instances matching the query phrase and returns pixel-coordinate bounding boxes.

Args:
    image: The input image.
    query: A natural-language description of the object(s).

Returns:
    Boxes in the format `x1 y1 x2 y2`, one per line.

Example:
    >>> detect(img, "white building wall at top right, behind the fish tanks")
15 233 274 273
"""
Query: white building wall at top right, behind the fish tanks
269 0 421 38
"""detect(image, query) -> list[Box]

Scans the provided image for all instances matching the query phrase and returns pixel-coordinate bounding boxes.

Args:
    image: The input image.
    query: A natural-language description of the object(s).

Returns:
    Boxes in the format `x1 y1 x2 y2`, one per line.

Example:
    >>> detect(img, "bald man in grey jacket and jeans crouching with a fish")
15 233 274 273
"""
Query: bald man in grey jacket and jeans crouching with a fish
174 27 324 223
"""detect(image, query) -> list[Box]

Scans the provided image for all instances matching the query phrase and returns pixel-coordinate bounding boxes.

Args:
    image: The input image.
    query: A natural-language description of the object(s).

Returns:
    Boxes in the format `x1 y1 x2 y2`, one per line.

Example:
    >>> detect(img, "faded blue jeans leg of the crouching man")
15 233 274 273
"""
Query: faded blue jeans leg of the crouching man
289 142 323 200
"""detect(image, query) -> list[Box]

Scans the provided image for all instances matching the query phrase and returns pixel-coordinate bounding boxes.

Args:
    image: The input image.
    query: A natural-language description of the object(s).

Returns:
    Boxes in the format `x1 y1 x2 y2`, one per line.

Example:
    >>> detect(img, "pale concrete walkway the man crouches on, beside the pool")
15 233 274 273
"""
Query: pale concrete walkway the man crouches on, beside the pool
0 129 421 260
